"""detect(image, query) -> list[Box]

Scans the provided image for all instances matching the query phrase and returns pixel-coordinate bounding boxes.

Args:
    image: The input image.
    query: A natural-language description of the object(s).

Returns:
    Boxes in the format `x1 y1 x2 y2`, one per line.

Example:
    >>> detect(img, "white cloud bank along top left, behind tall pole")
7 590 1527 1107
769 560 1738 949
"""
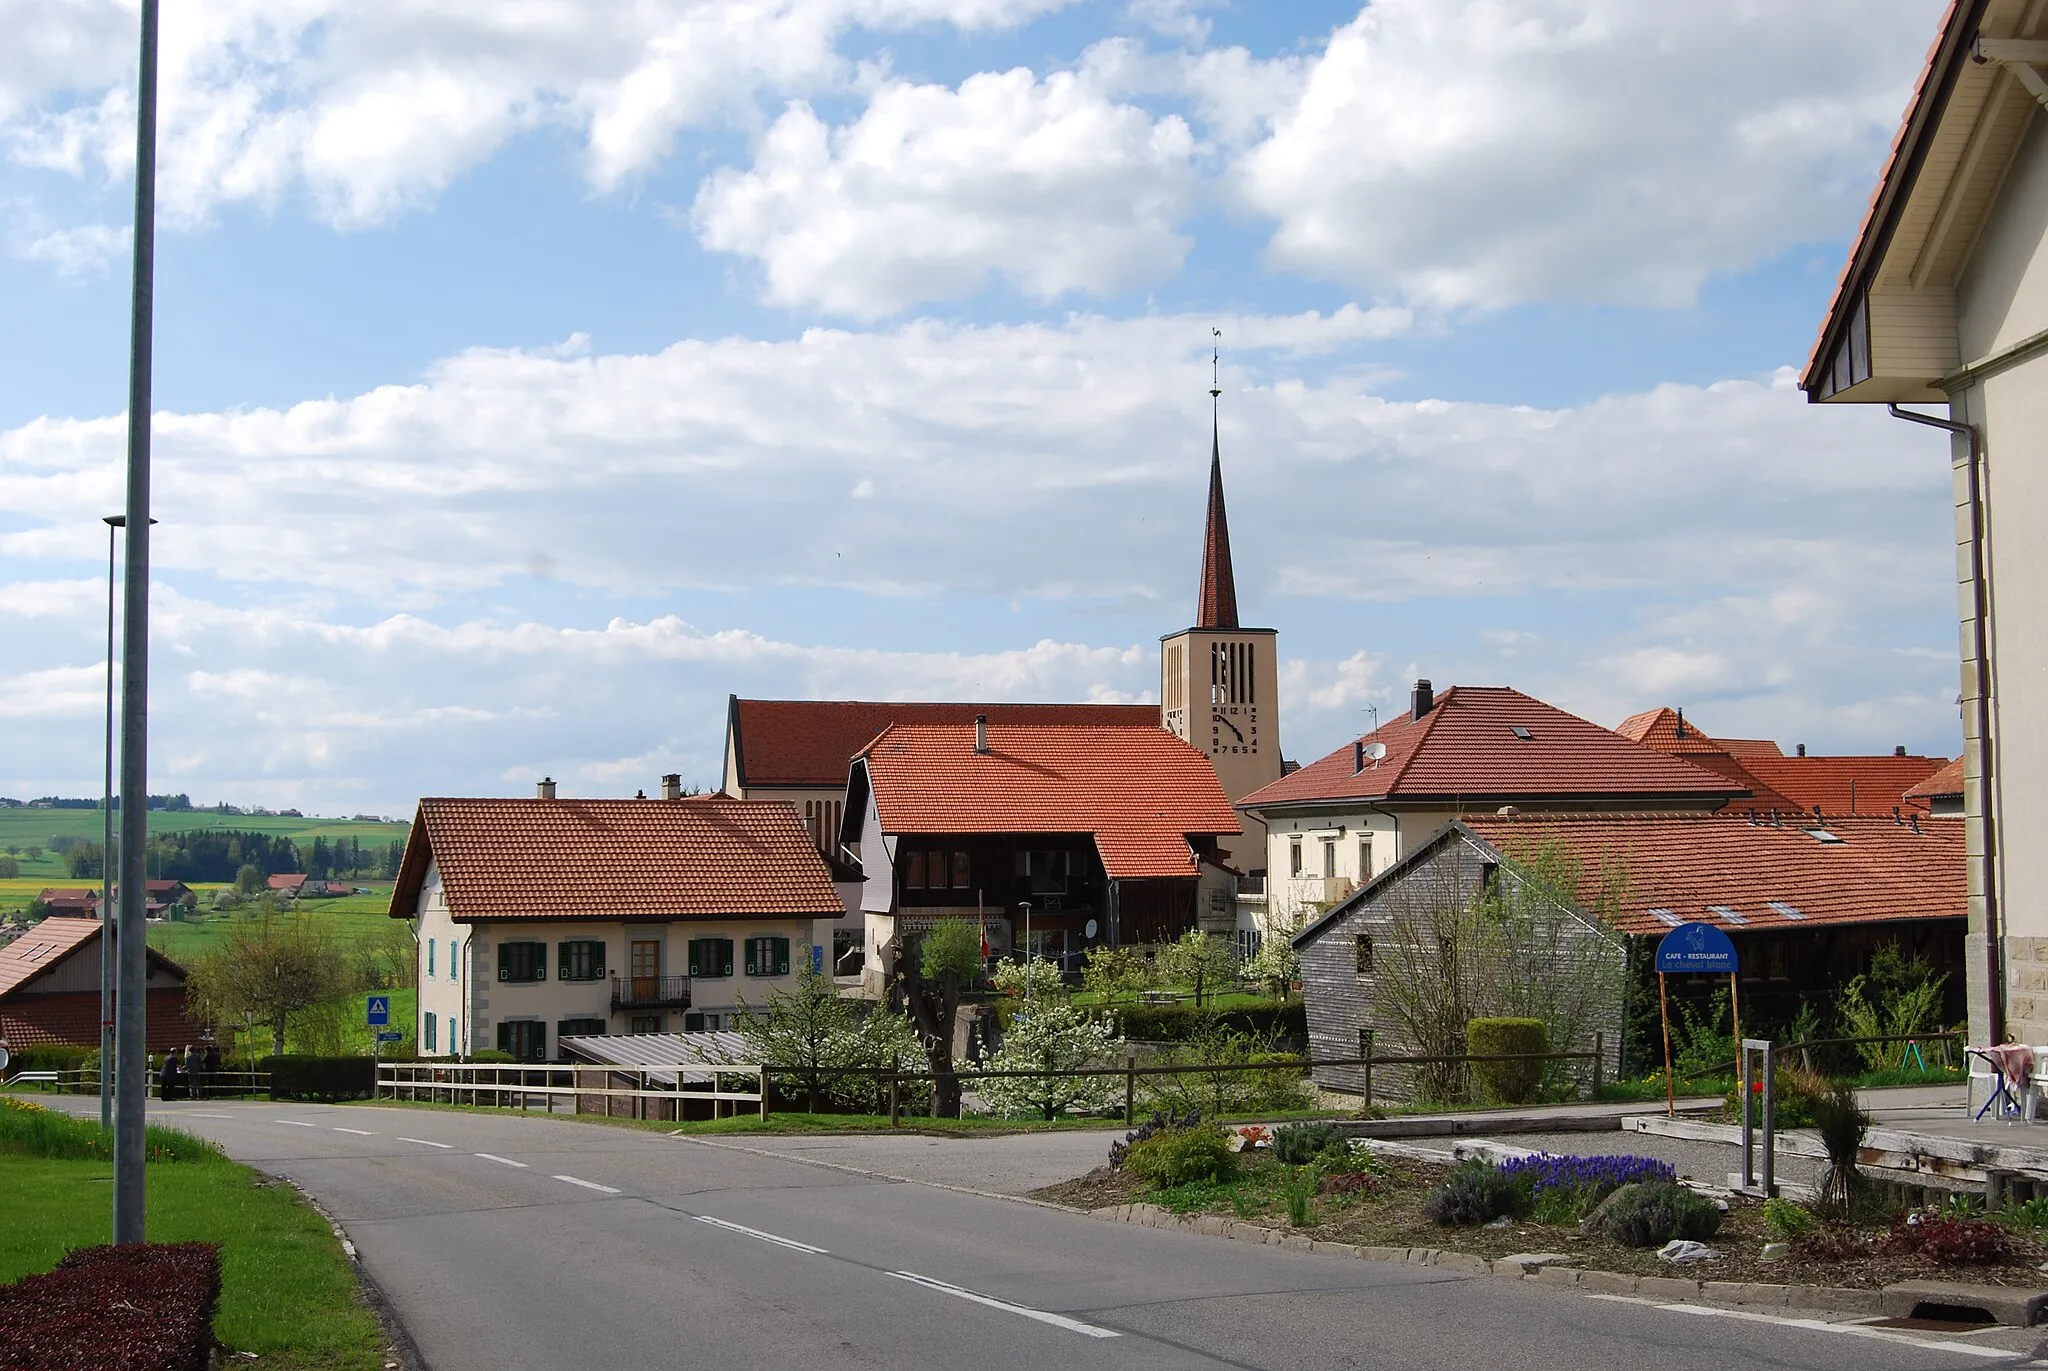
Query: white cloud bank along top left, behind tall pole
0 0 1069 225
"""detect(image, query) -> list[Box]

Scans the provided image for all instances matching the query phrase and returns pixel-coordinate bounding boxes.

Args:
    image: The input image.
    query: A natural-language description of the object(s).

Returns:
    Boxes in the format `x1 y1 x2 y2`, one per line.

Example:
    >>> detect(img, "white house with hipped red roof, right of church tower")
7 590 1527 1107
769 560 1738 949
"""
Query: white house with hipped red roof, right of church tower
1237 680 1751 937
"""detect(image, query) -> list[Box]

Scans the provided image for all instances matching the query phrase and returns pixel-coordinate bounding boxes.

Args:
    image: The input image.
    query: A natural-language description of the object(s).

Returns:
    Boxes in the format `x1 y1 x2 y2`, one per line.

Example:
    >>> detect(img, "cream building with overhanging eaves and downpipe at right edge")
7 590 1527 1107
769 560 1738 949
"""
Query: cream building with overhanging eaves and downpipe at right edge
1800 0 2048 1041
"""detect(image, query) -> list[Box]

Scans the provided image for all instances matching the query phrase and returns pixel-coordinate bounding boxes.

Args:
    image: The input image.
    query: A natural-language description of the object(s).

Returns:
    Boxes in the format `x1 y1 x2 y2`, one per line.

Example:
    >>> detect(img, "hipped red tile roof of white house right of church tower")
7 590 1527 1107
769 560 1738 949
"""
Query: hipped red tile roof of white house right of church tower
1237 687 1749 809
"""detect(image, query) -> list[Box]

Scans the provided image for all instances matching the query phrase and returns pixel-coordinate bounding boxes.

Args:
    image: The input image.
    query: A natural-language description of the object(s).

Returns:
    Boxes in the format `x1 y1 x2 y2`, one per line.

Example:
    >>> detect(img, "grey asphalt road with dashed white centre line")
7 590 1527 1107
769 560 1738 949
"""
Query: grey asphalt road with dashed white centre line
56 1103 2038 1371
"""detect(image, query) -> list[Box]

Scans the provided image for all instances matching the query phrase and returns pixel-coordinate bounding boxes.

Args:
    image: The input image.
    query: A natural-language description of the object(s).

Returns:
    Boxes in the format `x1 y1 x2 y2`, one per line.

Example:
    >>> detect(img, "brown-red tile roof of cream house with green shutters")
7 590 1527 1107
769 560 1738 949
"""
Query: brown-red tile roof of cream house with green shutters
391 795 846 922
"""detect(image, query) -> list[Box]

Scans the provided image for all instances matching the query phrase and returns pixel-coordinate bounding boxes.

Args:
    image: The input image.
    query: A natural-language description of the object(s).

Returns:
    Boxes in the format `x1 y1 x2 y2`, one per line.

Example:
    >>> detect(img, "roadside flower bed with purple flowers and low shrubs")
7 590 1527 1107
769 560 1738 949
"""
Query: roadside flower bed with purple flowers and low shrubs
1034 1148 2048 1289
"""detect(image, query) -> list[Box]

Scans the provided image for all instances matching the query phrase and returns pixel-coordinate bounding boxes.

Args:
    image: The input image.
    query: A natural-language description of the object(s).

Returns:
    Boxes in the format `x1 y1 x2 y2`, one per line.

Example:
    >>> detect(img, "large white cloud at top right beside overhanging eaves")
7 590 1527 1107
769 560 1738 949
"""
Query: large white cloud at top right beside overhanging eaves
1219 0 1942 307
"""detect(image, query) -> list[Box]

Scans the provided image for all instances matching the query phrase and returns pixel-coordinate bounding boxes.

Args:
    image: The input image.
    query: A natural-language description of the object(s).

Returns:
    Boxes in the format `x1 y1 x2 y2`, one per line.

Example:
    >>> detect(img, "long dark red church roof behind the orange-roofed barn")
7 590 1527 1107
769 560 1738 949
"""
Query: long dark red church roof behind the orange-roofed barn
727 697 1159 789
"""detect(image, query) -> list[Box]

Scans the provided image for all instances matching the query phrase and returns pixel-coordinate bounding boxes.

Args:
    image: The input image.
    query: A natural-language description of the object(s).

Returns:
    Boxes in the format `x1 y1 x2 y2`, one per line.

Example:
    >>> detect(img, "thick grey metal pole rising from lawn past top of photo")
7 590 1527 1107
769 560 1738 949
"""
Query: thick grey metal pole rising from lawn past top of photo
115 0 158 1244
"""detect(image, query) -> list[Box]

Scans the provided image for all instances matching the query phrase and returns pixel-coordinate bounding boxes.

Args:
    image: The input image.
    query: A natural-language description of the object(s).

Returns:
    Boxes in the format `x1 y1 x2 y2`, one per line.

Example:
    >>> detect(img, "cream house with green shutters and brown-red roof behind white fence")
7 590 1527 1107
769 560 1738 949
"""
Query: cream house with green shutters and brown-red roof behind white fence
391 781 854 1062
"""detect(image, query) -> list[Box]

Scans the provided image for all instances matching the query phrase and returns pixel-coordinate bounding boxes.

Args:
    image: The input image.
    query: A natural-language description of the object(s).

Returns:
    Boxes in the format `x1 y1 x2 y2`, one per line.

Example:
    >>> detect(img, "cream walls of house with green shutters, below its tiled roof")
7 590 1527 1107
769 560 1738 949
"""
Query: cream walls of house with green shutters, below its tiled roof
414 863 811 1060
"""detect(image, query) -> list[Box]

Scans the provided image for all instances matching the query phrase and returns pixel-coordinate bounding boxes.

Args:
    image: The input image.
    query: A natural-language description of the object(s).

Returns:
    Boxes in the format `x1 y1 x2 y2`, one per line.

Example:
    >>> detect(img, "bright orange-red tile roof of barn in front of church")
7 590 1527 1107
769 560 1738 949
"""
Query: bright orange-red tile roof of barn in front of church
860 719 1243 879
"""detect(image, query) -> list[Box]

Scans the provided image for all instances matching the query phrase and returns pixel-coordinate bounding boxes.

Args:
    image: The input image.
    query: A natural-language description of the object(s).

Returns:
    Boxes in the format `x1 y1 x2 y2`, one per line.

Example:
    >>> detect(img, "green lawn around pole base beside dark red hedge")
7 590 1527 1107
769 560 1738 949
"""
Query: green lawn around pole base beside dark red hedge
0 1156 385 1371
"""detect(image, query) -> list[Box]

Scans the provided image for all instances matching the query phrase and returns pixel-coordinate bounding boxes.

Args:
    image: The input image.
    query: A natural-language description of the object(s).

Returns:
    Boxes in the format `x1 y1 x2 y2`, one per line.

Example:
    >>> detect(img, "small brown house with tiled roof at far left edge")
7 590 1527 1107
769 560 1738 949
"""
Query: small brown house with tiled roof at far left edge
0 914 199 1051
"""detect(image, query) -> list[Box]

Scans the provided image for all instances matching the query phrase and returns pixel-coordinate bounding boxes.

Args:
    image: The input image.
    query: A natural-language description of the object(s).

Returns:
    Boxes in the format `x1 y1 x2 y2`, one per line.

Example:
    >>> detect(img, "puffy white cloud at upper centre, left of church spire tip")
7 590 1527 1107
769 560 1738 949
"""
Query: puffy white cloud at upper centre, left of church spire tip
692 68 1196 318
